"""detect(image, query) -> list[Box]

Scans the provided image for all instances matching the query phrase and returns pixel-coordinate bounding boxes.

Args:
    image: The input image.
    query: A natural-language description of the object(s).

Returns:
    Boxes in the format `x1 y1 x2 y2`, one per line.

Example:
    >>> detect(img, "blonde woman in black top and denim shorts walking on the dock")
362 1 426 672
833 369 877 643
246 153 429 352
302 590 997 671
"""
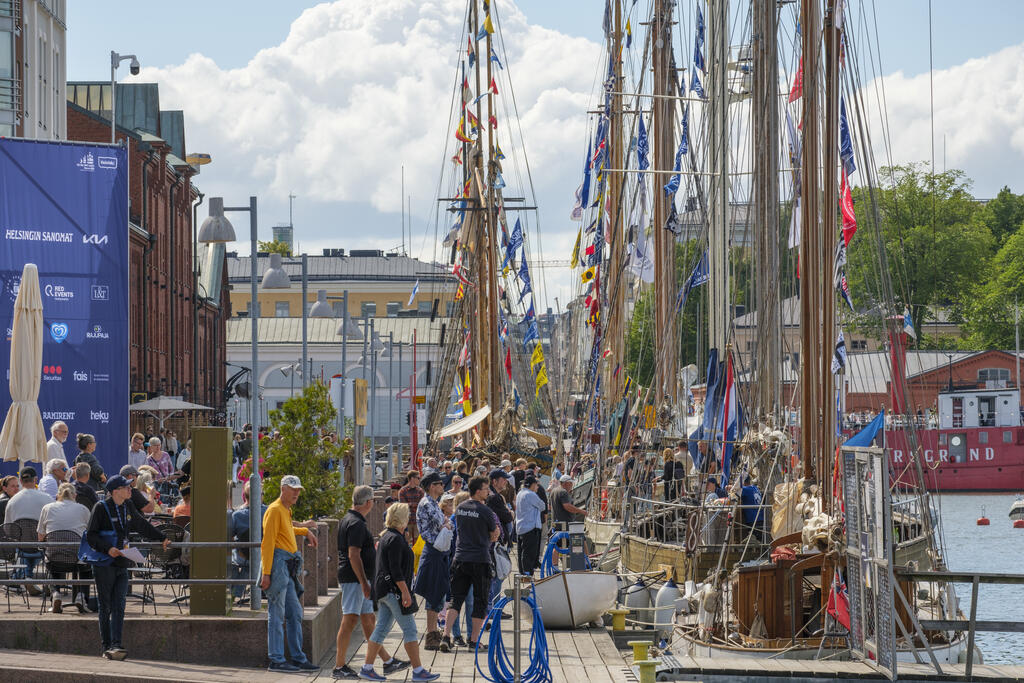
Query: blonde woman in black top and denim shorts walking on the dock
359 503 440 681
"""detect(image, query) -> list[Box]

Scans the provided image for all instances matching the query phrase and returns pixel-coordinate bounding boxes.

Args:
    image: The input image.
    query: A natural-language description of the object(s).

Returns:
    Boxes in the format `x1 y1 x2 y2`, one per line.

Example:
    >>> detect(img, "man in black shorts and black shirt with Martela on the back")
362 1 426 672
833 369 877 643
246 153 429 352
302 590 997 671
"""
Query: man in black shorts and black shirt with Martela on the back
438 477 502 652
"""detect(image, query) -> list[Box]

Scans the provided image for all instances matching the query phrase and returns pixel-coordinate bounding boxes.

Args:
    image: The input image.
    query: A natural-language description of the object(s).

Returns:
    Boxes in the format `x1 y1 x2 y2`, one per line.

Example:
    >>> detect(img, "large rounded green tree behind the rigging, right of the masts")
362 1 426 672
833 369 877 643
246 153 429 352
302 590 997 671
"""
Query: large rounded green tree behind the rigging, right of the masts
847 164 994 338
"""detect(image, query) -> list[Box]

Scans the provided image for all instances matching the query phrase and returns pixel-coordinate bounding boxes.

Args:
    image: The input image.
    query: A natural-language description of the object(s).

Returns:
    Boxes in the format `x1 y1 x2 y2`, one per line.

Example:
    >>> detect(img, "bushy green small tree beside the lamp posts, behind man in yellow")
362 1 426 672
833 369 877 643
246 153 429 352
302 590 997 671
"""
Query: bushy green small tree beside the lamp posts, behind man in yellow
260 380 352 519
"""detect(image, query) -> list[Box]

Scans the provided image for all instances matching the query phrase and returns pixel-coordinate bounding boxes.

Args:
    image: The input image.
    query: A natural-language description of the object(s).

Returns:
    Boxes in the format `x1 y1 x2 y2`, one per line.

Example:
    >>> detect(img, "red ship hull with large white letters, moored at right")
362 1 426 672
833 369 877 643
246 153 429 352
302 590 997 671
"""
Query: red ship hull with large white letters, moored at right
886 427 1024 492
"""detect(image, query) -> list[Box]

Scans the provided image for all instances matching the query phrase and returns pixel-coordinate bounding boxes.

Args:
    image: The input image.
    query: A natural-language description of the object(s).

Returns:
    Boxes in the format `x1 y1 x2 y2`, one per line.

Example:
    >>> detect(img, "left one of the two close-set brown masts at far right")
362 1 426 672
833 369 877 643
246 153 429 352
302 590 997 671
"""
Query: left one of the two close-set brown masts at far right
800 0 822 482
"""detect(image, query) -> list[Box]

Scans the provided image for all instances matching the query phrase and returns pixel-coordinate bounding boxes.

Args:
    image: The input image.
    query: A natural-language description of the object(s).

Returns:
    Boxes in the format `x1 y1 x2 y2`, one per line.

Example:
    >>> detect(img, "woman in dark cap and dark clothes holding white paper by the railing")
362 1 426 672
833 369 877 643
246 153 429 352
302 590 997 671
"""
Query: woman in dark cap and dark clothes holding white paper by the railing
79 474 171 660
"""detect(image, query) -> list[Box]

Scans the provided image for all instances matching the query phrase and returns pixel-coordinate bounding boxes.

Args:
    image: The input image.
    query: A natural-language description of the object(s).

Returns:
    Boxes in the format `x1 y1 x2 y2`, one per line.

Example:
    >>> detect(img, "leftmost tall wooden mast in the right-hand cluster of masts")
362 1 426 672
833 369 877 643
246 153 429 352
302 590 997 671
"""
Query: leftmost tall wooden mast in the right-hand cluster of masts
598 0 626 410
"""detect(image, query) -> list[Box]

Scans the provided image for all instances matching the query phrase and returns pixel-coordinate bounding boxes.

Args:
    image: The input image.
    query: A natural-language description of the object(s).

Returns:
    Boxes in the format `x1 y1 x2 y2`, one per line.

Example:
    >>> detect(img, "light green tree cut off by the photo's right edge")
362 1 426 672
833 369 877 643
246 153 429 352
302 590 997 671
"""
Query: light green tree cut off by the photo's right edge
965 225 1024 349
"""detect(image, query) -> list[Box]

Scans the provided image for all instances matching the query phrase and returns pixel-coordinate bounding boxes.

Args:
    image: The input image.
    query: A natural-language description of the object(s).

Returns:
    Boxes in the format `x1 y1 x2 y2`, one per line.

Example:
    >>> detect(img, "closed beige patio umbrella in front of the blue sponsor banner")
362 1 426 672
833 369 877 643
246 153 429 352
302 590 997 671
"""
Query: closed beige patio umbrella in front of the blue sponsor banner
0 263 46 463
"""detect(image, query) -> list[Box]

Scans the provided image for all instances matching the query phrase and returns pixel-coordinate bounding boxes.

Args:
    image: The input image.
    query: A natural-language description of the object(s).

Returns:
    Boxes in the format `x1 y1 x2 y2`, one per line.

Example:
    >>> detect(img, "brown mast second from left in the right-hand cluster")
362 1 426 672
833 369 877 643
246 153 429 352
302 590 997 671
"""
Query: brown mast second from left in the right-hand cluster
650 0 678 404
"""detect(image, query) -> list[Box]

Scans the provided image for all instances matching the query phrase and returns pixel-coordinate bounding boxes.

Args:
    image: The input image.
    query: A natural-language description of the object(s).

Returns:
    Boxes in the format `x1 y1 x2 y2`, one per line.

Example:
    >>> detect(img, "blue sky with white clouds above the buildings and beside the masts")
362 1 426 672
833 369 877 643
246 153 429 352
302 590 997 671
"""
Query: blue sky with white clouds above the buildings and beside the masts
68 0 1024 307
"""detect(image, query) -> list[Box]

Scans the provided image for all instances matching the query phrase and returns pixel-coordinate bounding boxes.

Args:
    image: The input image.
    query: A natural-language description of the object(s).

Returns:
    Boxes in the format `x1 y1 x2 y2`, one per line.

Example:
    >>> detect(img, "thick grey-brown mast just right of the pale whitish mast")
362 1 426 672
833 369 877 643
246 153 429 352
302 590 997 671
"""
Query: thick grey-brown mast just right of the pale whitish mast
752 2 782 426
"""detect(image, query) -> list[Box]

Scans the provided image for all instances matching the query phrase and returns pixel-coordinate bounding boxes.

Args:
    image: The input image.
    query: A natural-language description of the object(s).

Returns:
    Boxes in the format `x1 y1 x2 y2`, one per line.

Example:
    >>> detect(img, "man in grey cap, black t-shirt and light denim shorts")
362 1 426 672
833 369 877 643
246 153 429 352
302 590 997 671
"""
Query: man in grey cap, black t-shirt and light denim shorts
334 486 399 678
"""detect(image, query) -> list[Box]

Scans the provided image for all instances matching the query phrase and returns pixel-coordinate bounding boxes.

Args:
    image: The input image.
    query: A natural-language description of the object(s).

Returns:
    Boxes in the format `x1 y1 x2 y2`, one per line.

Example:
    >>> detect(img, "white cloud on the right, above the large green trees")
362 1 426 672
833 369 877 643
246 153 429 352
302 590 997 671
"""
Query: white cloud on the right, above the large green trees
866 44 1024 197
